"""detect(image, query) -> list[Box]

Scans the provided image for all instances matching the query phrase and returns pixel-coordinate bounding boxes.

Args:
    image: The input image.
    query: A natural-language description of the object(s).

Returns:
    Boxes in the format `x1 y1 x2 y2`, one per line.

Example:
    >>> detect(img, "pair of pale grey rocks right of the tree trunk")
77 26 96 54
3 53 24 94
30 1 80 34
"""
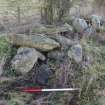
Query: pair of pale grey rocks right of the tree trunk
73 15 104 35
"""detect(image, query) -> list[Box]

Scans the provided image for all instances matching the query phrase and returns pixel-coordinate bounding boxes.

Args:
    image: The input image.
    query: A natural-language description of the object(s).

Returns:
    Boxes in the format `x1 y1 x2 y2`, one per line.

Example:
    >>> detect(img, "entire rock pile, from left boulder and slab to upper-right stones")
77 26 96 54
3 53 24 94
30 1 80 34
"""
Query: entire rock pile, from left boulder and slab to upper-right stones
0 15 102 84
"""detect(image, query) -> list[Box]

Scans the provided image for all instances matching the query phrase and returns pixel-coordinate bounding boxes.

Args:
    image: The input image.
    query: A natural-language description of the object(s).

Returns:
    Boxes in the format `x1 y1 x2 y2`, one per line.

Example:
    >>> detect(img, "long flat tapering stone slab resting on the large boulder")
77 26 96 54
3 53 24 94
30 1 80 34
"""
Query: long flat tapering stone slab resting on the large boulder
7 34 60 51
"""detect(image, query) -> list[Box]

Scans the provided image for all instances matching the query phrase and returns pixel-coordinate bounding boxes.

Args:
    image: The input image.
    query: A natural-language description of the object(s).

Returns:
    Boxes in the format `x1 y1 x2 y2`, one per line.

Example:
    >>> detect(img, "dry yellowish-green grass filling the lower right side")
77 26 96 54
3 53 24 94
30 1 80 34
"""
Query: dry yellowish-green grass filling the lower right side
79 41 105 105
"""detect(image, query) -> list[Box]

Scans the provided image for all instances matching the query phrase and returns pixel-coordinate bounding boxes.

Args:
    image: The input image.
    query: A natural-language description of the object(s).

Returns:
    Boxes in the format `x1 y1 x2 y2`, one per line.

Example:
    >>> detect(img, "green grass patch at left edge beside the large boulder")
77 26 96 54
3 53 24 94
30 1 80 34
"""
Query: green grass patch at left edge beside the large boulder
0 35 17 76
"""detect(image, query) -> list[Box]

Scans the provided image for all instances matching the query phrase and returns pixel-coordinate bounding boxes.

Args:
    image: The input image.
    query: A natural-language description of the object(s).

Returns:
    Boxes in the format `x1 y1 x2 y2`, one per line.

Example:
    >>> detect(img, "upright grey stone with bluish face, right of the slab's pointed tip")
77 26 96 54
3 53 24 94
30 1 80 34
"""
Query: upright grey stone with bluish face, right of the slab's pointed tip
68 44 83 63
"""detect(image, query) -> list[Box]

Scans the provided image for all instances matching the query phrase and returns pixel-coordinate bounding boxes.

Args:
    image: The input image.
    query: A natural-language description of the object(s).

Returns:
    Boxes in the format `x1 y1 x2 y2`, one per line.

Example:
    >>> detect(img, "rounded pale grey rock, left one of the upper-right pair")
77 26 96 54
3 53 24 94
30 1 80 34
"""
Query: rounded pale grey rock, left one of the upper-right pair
73 18 88 33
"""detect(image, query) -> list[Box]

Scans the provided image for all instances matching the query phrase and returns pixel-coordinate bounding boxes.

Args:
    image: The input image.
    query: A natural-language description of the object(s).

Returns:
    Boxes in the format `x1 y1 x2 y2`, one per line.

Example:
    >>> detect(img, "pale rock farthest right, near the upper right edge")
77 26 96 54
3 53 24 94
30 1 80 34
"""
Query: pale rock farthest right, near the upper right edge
91 15 102 29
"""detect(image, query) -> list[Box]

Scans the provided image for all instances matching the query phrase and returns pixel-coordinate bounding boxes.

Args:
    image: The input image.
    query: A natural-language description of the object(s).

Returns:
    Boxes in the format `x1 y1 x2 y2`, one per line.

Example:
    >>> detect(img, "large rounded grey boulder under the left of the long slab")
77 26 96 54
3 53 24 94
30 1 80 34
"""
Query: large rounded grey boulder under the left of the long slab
11 47 45 74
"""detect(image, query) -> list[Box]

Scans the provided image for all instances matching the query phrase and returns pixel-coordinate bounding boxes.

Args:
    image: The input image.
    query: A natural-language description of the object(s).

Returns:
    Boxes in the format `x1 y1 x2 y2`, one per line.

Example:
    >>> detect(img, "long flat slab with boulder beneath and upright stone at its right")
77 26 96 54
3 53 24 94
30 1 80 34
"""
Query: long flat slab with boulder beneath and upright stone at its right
7 34 82 74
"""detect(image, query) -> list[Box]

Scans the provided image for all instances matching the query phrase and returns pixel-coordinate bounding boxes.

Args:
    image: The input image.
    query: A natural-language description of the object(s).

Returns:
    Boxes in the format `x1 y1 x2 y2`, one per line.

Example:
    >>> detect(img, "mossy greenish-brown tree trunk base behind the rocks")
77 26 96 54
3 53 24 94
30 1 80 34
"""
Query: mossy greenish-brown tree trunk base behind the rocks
41 0 71 24
